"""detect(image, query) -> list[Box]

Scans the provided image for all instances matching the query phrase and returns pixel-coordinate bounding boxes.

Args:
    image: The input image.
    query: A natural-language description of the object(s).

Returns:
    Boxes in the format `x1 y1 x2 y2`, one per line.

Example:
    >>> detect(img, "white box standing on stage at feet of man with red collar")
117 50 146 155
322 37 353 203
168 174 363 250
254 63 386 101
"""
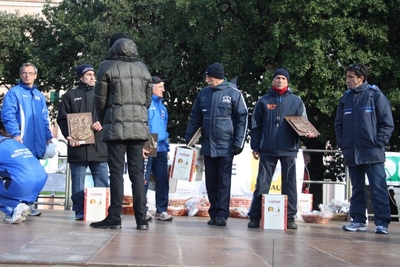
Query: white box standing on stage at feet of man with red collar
261 194 287 230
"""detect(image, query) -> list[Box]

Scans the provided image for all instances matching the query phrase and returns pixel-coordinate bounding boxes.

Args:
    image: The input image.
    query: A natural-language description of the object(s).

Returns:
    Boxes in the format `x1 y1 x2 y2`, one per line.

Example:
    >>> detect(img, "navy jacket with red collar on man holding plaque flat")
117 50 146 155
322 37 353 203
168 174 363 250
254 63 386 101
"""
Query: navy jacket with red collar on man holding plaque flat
250 88 307 157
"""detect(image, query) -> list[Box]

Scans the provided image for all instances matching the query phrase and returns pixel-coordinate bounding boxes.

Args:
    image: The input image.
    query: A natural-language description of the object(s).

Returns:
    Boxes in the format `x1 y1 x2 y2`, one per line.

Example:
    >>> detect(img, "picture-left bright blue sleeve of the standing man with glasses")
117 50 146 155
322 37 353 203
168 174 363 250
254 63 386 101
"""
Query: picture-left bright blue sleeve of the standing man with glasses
1 91 21 137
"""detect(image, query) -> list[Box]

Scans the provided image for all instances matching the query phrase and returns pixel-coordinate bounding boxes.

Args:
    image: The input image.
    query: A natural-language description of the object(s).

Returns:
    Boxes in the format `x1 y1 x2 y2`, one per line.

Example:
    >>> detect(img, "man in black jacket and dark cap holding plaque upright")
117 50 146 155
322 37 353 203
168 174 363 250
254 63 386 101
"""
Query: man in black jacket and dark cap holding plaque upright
57 64 109 220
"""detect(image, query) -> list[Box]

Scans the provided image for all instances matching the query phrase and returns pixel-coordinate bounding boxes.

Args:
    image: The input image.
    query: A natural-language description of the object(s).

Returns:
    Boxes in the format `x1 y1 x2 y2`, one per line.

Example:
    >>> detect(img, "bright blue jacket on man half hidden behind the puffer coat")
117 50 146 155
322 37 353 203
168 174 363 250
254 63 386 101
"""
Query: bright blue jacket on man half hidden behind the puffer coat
148 95 169 152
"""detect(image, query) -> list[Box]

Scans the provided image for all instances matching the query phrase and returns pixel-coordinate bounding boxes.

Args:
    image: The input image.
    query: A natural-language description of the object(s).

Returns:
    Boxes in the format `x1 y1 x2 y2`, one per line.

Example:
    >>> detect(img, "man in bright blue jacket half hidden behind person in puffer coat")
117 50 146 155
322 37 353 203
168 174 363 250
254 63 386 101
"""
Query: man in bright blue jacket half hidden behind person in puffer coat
144 76 173 221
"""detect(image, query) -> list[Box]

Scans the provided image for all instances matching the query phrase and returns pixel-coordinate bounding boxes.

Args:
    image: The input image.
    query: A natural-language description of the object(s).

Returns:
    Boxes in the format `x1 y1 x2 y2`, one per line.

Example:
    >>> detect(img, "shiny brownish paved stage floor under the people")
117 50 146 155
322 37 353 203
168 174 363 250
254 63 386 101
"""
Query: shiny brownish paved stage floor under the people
0 210 400 267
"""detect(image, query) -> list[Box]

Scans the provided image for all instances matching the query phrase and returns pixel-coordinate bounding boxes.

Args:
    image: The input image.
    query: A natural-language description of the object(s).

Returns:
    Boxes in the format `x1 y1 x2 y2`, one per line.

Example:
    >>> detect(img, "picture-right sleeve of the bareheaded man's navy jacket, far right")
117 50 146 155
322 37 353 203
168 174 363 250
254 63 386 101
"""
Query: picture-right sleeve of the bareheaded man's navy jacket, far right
375 93 394 146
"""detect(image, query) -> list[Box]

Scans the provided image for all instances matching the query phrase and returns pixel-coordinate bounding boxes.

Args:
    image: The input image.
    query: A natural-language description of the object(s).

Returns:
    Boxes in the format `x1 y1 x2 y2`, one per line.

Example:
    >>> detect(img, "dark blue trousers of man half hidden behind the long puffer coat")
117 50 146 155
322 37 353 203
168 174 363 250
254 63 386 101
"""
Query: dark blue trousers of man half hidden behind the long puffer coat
145 151 169 213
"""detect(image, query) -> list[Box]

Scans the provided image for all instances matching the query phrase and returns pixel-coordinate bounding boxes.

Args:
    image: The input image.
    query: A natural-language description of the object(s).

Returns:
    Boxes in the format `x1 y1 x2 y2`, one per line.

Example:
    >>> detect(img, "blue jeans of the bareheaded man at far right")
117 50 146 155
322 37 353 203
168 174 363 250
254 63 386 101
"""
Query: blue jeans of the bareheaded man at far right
348 163 391 227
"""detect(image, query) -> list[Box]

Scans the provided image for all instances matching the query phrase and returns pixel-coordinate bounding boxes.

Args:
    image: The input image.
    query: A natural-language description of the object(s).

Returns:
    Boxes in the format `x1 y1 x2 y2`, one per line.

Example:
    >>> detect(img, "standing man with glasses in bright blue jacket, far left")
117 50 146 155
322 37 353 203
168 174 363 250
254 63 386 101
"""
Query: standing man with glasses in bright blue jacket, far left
1 63 53 216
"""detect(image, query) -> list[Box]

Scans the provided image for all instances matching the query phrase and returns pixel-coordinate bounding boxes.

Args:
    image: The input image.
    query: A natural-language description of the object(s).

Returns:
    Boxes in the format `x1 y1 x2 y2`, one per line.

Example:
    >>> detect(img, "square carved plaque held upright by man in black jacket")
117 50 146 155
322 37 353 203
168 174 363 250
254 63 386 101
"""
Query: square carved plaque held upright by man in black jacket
67 112 95 145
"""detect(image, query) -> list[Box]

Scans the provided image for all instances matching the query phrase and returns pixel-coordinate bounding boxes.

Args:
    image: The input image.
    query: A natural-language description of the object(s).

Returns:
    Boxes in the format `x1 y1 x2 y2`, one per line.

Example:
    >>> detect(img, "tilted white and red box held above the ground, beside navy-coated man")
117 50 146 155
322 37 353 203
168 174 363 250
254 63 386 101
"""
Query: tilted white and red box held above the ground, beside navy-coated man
171 146 204 182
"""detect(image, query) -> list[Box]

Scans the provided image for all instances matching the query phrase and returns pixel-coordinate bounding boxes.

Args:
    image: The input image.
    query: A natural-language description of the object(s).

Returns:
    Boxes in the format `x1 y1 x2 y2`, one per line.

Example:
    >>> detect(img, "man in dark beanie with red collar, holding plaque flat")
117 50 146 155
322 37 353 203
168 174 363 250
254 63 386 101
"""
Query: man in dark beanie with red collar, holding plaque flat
248 69 316 229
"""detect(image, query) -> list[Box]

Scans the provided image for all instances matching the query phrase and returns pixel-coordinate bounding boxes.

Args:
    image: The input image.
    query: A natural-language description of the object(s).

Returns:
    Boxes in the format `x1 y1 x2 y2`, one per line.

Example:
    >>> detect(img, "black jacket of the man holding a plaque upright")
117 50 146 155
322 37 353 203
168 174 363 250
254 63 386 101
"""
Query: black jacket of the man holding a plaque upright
57 82 107 163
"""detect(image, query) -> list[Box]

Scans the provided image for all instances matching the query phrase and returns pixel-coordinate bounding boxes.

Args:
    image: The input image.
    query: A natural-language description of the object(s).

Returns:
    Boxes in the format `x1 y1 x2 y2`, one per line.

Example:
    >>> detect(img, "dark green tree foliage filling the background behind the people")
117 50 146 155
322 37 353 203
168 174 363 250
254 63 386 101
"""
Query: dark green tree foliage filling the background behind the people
0 0 400 151
